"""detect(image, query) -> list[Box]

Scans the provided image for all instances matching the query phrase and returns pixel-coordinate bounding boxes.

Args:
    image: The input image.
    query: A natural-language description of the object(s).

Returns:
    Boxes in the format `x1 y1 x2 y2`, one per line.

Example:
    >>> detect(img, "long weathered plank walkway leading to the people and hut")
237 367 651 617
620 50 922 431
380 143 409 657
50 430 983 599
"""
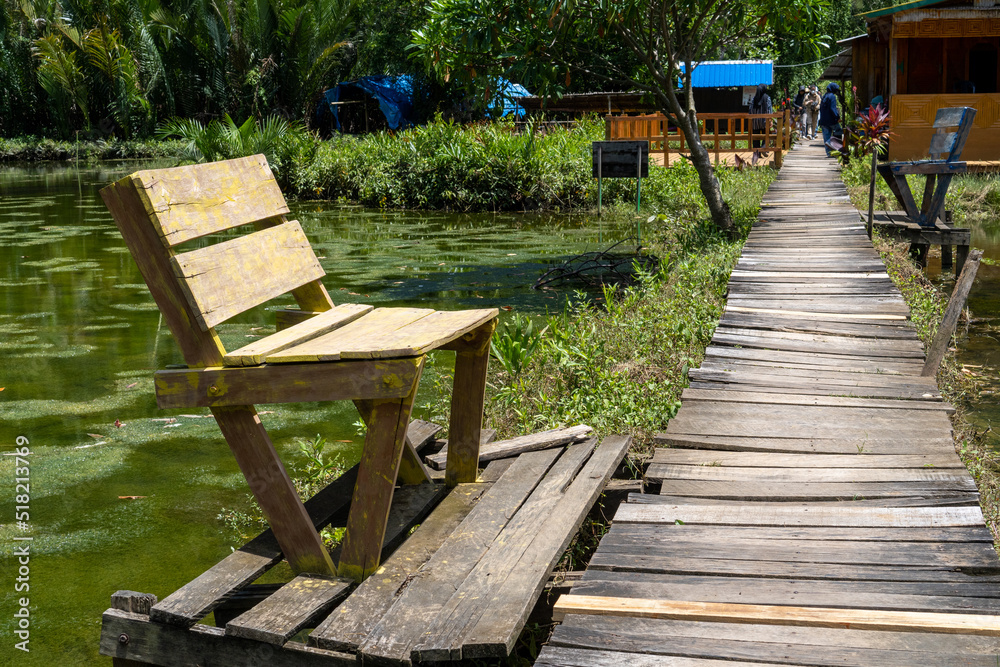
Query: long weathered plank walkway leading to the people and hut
536 142 1000 667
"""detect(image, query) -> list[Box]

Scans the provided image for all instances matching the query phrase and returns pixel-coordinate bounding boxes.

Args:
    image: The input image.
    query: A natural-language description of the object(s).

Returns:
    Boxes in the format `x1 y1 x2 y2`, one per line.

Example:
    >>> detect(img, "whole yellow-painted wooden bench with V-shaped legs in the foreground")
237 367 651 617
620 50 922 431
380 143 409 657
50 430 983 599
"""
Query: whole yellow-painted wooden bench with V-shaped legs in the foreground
101 155 497 581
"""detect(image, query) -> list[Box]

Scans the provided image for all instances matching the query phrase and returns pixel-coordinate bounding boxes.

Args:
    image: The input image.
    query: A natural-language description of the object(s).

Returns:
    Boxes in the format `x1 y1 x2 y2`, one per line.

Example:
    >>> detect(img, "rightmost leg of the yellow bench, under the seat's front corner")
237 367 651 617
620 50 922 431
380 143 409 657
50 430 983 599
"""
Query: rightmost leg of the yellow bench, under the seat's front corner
445 320 496 487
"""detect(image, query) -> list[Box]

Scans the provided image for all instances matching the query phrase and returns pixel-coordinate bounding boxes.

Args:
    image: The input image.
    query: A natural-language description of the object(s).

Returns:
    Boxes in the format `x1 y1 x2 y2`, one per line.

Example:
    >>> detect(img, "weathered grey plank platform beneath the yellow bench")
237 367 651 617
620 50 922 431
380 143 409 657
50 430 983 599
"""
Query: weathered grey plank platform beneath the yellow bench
101 436 631 667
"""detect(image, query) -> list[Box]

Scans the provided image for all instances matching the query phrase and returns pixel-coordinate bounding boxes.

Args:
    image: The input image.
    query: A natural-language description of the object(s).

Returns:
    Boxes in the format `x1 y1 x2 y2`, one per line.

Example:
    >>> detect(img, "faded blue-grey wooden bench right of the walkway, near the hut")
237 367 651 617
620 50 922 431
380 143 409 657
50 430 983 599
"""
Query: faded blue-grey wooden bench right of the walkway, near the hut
878 107 976 229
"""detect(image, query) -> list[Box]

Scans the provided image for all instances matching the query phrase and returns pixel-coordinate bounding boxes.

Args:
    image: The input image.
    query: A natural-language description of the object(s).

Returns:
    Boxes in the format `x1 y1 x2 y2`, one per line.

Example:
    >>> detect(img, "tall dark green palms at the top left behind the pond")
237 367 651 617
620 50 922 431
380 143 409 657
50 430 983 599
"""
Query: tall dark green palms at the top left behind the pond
0 0 386 138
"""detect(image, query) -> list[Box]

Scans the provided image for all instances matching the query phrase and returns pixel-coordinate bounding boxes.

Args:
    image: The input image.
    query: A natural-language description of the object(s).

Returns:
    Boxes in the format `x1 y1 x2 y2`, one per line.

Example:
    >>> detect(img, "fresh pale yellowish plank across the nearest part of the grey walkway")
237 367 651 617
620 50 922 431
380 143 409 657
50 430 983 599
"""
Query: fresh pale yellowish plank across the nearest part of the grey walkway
552 594 1000 637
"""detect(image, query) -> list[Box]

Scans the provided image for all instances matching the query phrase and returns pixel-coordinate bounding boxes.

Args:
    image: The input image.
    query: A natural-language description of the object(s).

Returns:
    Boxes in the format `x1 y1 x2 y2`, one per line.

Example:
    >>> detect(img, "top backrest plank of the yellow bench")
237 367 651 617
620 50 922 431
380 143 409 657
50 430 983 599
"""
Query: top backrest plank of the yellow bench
131 155 288 247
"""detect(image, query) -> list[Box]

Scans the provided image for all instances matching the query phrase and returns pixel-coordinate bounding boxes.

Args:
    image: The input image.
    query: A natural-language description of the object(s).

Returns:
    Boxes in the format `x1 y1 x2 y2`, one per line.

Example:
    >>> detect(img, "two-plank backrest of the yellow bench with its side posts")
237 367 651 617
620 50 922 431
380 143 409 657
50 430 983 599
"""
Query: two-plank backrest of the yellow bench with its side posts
101 155 332 365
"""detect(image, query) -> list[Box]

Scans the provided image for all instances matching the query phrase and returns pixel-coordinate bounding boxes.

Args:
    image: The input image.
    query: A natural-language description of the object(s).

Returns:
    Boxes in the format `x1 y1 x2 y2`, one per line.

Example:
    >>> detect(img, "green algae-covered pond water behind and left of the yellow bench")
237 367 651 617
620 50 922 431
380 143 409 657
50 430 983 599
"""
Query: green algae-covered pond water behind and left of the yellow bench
0 163 622 665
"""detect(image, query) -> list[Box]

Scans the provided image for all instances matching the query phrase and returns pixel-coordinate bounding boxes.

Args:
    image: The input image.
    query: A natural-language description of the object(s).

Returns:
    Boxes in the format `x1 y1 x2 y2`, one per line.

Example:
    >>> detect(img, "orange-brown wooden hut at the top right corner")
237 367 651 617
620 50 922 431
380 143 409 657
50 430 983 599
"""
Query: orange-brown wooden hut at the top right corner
846 0 1000 166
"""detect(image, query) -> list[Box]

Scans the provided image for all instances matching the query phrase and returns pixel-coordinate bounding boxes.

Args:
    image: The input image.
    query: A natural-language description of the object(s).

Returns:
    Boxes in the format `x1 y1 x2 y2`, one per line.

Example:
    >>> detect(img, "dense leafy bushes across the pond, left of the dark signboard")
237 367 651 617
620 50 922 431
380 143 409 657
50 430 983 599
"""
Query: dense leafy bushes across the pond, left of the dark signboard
287 118 604 211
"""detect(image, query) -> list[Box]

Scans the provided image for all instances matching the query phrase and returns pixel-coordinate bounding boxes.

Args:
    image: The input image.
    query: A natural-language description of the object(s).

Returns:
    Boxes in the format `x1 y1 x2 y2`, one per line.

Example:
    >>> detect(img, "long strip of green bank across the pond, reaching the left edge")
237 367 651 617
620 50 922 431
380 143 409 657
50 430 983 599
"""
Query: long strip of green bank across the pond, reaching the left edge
0 119 672 214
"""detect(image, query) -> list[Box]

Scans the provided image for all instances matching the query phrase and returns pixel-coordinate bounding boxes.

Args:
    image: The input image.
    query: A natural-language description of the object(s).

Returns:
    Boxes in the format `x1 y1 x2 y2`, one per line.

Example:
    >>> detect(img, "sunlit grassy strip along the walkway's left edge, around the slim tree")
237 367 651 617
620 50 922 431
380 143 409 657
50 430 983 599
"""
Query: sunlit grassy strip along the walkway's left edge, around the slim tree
487 162 774 443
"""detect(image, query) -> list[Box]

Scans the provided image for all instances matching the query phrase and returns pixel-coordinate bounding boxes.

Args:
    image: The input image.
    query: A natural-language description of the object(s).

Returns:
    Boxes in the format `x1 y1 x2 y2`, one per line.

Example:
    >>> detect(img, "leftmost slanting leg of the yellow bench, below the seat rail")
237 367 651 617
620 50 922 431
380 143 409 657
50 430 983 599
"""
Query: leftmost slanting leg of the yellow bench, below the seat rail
212 405 335 574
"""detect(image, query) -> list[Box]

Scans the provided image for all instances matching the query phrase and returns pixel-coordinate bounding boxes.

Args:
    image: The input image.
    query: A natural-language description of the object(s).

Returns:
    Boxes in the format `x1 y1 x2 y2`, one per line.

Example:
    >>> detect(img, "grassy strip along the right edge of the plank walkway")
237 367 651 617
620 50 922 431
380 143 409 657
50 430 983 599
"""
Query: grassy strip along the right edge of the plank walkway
844 161 1000 548
